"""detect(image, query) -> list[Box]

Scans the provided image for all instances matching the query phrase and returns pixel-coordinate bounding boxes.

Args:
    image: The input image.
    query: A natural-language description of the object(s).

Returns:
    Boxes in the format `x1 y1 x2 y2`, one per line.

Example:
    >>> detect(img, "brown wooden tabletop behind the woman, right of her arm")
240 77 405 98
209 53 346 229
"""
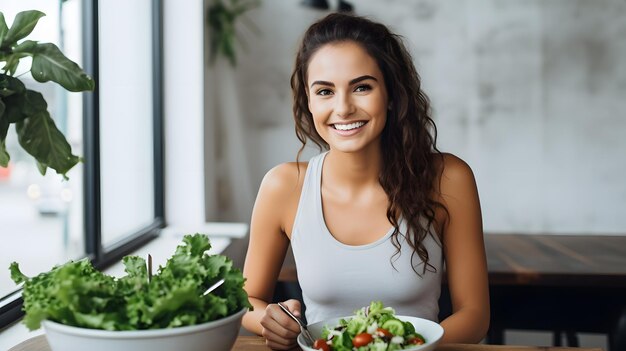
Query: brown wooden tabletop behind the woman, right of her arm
485 234 626 288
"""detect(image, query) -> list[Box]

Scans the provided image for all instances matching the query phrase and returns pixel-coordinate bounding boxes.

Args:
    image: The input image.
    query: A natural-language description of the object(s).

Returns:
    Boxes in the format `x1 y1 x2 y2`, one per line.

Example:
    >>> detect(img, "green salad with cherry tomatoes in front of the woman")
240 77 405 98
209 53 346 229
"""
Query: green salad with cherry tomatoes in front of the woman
313 301 426 351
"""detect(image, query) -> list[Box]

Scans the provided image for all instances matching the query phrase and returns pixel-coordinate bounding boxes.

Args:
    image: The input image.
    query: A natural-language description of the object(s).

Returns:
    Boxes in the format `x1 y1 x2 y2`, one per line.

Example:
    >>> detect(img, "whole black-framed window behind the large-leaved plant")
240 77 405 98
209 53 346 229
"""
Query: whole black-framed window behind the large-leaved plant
0 0 164 328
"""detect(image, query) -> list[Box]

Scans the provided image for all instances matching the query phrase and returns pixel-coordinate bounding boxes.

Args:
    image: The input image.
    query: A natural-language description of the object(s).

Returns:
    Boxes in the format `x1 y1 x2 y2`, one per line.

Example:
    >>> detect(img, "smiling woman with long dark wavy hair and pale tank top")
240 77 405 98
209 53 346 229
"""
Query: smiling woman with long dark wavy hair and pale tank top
243 14 489 349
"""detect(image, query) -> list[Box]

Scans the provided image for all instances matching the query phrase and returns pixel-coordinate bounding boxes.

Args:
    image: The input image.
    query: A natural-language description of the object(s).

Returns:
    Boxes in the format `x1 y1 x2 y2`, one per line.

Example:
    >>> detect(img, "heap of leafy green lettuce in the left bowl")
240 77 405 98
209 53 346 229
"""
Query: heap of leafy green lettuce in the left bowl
10 234 252 330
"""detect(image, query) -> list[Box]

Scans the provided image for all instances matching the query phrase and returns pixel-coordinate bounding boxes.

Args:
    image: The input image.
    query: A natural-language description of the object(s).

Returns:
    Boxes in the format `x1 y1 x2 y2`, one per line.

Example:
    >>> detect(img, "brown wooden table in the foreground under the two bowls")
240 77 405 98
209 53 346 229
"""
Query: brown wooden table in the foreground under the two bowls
9 335 602 351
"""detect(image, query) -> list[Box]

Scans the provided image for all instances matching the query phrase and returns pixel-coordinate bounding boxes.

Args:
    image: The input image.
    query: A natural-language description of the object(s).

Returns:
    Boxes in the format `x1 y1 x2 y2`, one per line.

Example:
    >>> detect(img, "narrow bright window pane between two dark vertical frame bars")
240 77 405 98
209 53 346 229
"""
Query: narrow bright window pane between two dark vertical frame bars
98 0 160 246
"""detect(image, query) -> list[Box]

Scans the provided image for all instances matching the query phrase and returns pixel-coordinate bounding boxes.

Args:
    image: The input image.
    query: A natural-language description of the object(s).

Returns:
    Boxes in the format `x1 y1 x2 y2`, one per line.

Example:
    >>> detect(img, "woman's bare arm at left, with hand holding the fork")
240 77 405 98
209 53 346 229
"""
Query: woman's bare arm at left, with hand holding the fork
243 164 300 349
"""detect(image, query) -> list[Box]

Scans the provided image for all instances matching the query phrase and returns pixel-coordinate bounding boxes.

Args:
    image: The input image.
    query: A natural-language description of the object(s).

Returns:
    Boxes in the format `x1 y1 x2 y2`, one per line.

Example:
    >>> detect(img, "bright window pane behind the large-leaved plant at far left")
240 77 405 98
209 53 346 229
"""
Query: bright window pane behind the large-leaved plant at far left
0 0 84 297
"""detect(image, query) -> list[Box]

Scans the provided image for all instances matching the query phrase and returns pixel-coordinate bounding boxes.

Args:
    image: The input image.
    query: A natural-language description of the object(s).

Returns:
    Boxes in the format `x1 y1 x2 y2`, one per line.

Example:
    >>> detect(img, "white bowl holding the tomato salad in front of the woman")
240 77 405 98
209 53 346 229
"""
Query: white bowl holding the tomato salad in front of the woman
297 316 443 351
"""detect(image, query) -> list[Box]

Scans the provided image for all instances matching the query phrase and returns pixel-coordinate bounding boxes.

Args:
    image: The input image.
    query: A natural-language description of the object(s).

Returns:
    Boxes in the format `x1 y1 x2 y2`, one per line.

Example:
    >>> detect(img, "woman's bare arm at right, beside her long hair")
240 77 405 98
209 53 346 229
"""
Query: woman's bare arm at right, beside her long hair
440 155 490 343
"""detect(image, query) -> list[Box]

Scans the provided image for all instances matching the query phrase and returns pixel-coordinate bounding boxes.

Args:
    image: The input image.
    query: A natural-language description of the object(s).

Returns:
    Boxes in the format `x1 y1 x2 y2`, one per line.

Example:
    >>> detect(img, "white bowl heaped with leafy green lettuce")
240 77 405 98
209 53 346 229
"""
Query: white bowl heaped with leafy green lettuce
43 308 247 351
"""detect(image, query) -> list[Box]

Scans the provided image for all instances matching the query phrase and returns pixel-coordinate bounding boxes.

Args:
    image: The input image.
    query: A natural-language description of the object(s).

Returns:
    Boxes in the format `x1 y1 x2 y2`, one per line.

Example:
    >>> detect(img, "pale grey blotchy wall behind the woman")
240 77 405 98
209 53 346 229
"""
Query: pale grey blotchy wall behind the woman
217 0 626 234
